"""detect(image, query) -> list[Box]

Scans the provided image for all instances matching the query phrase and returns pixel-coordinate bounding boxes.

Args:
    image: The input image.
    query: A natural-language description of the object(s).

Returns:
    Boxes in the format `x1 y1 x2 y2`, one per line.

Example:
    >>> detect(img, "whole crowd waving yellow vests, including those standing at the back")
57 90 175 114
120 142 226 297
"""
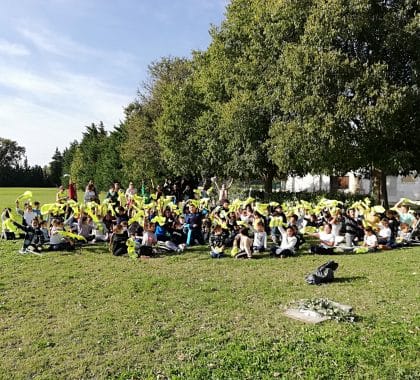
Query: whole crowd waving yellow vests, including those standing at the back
1 179 419 259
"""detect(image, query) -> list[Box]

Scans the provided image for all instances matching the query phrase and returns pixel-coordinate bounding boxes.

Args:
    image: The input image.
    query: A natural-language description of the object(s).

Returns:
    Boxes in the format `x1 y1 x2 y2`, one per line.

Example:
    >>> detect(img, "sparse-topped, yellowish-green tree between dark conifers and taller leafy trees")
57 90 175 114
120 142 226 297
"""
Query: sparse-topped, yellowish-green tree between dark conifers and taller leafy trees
122 58 197 184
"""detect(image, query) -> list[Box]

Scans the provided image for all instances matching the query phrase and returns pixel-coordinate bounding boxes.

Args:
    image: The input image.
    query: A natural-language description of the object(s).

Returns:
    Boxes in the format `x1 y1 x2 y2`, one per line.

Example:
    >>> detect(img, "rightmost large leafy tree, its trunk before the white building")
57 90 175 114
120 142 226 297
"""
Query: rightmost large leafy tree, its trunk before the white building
271 0 420 202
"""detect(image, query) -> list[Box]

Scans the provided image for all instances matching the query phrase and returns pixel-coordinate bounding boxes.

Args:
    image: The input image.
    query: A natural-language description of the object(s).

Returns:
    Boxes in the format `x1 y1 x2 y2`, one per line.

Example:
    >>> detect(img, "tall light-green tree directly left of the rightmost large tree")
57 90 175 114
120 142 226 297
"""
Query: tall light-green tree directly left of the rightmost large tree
193 0 310 192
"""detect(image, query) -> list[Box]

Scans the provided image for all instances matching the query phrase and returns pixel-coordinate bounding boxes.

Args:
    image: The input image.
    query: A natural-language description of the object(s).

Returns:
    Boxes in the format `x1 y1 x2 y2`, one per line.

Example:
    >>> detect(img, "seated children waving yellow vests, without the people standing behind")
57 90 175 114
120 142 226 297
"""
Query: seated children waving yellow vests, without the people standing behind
1 181 419 258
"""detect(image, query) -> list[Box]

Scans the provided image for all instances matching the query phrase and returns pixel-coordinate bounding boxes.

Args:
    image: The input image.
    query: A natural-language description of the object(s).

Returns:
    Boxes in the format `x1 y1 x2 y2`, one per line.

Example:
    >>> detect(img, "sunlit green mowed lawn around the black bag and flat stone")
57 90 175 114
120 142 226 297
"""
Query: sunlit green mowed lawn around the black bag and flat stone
0 189 420 379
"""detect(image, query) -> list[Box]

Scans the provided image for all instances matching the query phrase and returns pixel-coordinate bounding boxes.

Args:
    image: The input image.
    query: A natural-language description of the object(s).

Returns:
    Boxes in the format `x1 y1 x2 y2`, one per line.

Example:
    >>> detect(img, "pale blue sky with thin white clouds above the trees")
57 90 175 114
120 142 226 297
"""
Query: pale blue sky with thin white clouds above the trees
0 0 227 166
